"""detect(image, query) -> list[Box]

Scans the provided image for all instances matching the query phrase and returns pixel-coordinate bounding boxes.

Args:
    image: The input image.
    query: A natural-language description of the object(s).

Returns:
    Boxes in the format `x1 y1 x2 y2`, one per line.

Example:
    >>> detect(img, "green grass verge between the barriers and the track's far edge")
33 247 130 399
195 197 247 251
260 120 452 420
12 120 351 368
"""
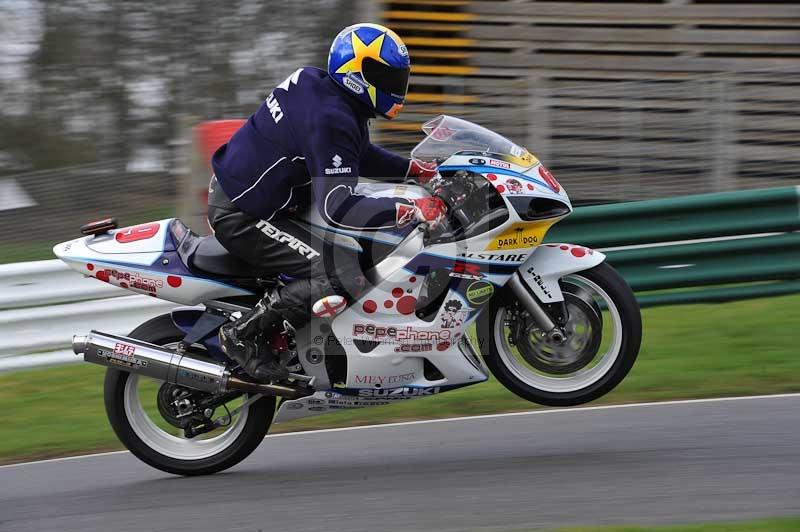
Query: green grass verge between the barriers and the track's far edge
0 296 800 463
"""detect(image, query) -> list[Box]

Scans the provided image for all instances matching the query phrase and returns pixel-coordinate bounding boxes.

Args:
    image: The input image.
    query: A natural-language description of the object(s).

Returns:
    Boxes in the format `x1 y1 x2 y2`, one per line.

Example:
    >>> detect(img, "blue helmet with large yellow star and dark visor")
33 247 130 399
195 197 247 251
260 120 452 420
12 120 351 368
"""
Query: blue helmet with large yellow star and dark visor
328 23 411 119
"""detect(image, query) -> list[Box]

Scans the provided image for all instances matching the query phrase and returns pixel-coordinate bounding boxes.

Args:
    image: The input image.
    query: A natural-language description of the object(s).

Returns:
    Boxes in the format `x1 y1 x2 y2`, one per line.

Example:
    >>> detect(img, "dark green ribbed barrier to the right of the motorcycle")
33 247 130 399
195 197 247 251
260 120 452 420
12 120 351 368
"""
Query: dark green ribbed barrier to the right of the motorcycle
546 187 800 306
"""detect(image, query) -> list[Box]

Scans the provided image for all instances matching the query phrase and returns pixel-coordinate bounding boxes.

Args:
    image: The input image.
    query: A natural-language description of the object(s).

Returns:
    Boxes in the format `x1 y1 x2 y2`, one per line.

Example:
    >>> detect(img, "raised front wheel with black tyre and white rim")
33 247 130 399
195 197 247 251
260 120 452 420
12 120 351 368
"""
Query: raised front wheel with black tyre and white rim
478 263 642 406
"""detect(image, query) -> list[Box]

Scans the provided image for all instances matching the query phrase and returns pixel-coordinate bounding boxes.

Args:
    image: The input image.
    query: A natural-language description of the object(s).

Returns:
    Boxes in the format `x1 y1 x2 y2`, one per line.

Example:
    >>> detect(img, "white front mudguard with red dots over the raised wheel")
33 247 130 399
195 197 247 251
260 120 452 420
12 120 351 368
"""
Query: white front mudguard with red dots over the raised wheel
519 244 606 303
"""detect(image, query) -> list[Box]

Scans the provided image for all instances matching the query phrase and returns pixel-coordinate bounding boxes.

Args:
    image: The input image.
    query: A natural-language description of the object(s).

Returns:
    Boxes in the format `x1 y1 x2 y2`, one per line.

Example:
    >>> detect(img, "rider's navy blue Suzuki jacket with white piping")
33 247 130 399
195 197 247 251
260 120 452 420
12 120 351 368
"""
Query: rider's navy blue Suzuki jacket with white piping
212 67 411 229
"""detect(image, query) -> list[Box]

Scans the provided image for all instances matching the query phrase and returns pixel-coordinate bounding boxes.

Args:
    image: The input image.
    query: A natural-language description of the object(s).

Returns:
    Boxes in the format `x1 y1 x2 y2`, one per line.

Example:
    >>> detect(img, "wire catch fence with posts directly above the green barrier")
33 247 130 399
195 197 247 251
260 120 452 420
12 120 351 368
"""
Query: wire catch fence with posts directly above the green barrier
373 70 800 204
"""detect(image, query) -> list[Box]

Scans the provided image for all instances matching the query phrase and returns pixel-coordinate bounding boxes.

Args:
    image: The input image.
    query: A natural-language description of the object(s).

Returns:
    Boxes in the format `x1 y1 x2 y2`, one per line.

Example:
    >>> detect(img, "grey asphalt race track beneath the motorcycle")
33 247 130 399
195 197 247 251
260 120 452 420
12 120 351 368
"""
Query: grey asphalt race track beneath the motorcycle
0 394 800 532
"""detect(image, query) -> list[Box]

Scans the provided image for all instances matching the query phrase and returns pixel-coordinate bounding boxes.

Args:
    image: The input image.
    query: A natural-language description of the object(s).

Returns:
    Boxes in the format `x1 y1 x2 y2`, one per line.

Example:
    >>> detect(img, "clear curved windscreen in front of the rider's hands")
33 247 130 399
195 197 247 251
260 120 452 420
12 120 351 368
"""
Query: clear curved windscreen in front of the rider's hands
411 115 536 167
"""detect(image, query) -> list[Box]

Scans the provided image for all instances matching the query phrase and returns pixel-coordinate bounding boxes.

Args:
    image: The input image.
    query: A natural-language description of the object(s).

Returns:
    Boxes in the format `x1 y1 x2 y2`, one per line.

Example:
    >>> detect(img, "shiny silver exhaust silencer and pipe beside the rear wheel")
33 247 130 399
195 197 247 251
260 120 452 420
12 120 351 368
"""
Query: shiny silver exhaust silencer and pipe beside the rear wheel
72 331 313 399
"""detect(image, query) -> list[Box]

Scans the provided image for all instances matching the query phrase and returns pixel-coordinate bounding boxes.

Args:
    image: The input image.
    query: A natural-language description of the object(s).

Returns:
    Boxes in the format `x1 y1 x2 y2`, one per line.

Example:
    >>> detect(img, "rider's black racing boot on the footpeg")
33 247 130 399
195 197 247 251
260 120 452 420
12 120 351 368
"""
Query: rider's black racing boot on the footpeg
219 292 289 382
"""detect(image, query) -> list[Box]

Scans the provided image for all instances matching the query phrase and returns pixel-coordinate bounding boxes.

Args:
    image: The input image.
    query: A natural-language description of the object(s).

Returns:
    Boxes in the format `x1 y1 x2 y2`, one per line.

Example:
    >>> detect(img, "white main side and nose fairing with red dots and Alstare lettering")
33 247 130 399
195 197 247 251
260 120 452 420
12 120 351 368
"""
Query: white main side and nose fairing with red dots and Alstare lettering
276 155 571 420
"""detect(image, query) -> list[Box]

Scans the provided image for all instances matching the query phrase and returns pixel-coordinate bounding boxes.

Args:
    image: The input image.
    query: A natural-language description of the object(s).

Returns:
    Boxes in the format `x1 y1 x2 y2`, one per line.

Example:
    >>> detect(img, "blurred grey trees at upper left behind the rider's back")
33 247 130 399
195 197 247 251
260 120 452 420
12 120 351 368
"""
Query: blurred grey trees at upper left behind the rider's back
0 0 353 176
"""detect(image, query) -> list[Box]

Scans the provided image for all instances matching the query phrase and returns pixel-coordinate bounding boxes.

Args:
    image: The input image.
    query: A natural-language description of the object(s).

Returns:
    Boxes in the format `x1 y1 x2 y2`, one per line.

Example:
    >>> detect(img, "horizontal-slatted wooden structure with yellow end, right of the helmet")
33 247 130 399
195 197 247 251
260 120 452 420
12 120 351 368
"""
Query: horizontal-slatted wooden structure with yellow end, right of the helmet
377 0 800 202
